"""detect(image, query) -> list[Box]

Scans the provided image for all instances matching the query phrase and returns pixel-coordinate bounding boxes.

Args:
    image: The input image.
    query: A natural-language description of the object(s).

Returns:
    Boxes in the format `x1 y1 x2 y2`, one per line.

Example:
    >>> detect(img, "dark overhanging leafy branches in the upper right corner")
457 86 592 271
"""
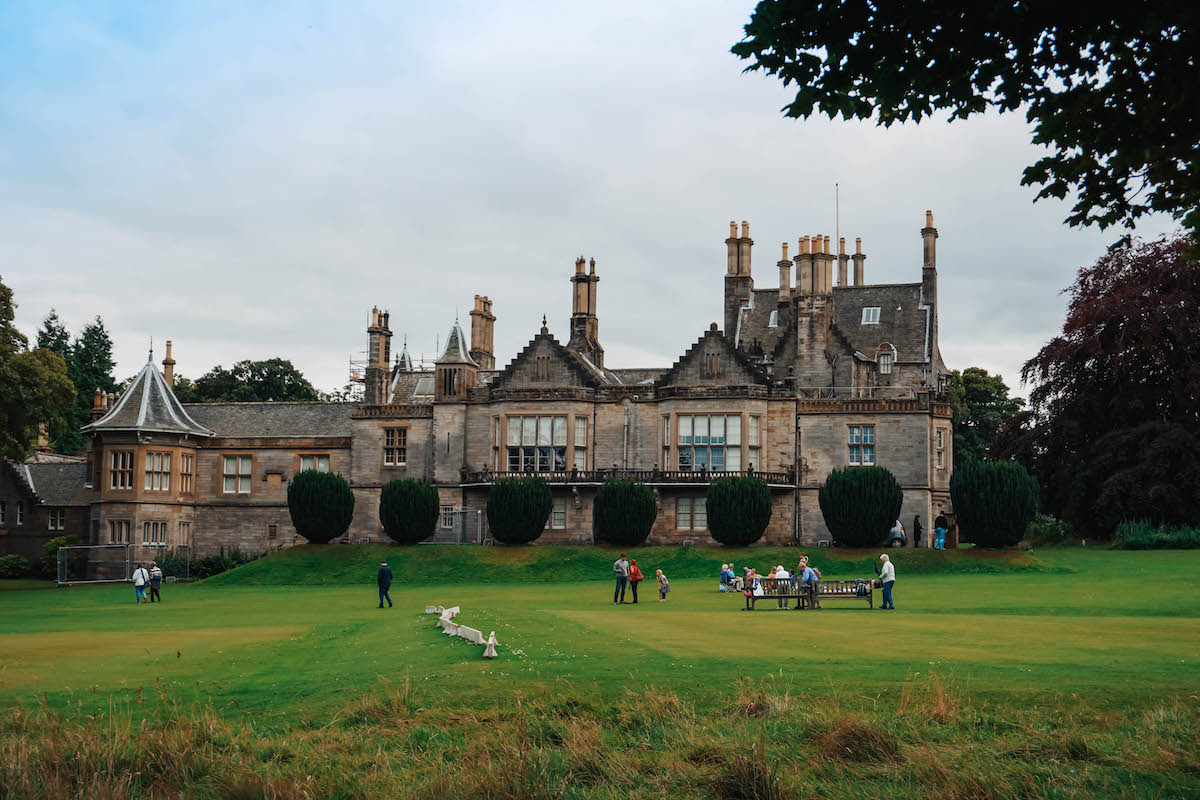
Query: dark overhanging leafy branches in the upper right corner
733 0 1200 242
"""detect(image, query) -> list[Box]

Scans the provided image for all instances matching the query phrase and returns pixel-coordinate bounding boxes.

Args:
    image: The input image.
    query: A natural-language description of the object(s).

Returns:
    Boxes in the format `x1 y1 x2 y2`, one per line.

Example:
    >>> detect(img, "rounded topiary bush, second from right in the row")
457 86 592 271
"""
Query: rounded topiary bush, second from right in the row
817 467 904 547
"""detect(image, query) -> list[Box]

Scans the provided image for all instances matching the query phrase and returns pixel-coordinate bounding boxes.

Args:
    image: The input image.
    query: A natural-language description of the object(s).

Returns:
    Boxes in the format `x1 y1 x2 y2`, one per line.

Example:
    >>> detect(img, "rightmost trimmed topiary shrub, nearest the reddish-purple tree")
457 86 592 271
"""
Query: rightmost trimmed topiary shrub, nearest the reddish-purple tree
950 461 1040 547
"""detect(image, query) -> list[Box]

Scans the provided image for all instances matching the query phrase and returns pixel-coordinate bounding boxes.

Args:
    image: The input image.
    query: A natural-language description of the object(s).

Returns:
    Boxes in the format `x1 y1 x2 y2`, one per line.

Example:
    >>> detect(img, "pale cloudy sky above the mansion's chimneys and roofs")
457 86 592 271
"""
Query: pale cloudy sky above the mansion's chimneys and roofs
0 0 1177 395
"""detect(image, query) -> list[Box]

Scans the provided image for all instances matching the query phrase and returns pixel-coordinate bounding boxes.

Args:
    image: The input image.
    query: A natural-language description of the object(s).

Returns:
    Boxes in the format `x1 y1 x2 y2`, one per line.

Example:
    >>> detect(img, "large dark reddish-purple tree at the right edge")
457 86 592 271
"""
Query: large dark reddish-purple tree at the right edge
991 236 1200 537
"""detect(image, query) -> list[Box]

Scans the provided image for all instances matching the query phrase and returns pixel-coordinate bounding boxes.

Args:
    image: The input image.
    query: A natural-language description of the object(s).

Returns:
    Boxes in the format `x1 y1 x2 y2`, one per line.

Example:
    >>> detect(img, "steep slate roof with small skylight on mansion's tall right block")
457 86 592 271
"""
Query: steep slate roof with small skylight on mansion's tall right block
833 283 932 362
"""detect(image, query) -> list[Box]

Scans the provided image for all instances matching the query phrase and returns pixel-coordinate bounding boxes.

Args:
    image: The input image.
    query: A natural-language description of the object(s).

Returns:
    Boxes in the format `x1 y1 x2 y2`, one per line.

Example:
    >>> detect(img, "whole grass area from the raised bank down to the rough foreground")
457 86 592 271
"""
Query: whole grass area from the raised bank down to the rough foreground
0 546 1200 798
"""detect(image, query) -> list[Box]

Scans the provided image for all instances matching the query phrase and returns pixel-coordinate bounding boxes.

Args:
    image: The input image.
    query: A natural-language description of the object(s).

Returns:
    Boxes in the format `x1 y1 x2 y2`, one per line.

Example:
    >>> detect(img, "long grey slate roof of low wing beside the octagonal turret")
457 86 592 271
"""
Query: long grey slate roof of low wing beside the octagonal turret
184 402 350 437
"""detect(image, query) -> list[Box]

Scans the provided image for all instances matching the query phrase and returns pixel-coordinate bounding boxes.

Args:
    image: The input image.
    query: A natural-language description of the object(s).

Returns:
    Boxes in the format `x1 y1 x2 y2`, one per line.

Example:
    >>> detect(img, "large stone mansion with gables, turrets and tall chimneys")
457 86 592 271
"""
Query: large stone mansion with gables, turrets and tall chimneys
0 211 953 563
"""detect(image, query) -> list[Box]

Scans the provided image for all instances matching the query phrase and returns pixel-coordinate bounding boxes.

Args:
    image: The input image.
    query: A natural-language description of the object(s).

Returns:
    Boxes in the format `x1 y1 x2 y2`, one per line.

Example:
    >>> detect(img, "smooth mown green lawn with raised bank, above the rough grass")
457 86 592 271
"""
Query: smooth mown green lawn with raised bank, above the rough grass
0 548 1200 796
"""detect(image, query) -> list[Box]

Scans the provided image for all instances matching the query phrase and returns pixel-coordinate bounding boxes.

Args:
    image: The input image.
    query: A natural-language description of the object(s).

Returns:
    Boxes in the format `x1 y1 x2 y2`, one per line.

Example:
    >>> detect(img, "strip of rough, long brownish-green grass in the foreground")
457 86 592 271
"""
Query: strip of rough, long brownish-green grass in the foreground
0 675 1200 800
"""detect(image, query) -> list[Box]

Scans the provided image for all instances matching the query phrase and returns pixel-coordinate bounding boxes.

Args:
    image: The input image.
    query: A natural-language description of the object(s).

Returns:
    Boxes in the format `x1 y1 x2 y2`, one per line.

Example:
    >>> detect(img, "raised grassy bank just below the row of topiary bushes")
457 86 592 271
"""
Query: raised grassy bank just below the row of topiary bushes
205 545 1064 585
